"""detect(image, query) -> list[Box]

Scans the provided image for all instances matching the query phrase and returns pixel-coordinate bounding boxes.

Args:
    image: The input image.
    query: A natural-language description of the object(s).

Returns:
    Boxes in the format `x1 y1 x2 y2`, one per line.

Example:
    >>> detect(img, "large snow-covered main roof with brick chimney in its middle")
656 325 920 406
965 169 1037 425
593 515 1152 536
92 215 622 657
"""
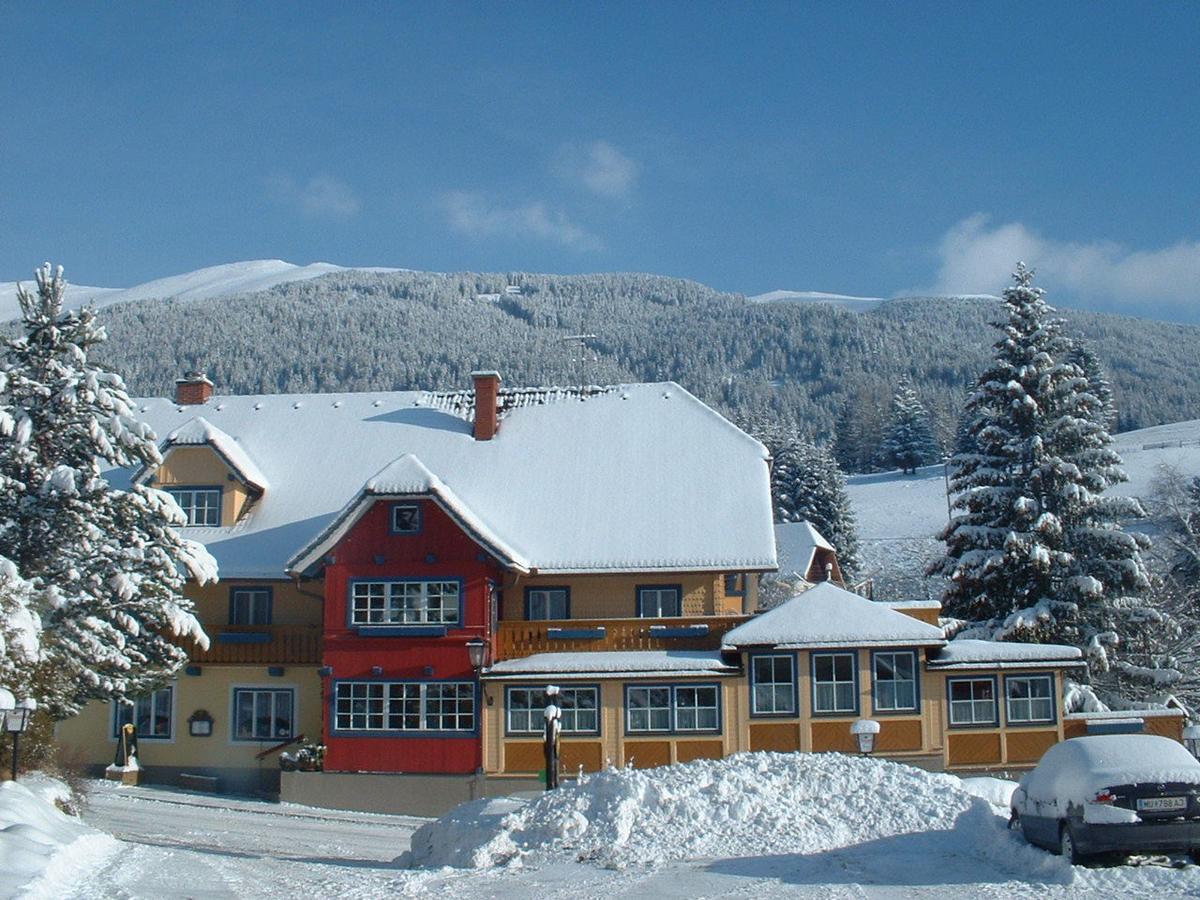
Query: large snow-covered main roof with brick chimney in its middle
113 382 775 578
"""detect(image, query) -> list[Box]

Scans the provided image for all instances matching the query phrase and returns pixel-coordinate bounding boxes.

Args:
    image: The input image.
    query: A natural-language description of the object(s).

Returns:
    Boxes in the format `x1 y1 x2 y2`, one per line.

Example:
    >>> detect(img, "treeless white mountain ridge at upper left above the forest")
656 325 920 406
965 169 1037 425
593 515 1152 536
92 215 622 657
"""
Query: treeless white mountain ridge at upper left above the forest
0 259 406 322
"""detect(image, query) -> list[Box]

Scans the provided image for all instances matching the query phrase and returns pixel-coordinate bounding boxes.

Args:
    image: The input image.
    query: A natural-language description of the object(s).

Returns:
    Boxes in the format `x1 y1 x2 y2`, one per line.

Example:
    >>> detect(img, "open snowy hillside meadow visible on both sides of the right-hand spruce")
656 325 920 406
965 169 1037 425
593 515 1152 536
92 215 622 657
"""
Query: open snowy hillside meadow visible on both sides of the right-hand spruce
846 420 1200 600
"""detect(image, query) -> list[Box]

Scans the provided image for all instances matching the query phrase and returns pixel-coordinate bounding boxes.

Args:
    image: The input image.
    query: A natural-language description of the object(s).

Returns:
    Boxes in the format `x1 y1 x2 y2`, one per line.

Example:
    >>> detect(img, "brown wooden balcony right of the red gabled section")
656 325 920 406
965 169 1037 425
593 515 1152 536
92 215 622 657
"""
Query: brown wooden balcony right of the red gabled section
496 616 749 659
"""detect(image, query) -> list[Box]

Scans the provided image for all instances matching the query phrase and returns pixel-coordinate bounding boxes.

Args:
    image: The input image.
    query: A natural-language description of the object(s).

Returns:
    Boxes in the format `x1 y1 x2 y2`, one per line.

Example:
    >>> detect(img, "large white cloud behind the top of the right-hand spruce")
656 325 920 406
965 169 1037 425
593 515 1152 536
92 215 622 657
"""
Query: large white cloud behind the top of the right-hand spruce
928 214 1200 318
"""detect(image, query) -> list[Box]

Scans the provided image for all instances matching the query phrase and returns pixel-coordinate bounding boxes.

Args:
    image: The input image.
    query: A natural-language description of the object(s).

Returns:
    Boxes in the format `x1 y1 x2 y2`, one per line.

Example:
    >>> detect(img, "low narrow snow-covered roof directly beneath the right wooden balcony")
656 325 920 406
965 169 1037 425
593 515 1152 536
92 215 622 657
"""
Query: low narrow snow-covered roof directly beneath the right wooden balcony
484 650 742 680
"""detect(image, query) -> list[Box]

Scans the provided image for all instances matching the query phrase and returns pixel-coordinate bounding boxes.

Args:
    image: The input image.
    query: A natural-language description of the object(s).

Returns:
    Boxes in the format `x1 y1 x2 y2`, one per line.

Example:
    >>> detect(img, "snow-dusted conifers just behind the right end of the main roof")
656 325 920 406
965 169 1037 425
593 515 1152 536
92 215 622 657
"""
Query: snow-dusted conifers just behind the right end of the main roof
757 428 862 578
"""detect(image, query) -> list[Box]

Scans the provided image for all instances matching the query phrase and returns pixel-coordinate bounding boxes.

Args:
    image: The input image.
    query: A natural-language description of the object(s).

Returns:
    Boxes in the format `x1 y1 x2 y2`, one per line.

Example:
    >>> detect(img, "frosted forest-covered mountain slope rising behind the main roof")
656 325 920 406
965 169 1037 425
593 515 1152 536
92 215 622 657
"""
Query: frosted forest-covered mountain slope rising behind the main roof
88 271 1200 448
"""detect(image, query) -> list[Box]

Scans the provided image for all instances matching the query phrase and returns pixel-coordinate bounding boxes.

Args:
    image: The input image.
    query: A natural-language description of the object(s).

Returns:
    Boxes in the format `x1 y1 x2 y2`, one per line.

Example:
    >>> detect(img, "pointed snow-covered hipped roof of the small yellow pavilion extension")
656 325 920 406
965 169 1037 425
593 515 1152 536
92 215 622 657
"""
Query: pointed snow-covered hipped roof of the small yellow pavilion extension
722 581 944 649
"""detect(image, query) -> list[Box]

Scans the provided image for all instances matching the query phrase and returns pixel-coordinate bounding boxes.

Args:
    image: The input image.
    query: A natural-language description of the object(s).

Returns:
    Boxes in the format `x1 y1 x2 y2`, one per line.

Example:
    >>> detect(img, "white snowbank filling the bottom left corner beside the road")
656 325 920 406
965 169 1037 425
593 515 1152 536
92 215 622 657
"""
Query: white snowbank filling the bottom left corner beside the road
0 776 118 898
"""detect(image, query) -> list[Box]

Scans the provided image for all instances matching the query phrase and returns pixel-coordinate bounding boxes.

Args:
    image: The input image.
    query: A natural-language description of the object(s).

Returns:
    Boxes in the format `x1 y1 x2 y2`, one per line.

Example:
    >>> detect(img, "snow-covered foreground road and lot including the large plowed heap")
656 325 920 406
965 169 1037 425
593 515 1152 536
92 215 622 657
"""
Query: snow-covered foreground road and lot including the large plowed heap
18 754 1200 900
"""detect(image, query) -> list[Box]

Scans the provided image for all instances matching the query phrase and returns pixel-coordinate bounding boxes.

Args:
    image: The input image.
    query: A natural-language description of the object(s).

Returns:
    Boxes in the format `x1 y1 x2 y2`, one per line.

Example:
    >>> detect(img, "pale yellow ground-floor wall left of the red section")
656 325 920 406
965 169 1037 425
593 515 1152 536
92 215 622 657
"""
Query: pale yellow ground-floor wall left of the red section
55 666 322 769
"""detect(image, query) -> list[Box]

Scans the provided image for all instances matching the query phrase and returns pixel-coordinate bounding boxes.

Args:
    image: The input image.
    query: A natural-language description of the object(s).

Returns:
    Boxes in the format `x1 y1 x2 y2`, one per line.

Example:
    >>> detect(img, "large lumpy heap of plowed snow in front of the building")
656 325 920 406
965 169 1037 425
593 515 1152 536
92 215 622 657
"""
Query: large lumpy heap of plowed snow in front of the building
401 754 995 869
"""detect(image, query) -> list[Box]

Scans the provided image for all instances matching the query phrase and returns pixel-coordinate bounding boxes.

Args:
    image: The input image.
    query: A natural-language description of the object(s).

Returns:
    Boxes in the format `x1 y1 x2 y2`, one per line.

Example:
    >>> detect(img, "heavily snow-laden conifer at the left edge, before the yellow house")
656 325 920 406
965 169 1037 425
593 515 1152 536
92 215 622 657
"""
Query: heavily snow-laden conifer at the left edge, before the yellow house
0 264 216 716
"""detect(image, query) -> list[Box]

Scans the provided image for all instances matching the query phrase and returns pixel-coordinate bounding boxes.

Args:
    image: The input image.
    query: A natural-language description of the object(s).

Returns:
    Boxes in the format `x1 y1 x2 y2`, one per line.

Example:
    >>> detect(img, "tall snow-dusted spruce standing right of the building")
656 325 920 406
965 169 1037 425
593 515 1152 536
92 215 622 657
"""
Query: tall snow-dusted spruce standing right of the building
928 265 1172 696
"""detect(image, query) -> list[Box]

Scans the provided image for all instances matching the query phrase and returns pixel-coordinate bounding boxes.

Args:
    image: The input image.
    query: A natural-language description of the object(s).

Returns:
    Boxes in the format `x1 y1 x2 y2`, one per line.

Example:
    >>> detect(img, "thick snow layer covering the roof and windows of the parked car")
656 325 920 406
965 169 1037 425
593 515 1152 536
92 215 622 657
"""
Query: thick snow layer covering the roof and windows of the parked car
1021 734 1200 804
